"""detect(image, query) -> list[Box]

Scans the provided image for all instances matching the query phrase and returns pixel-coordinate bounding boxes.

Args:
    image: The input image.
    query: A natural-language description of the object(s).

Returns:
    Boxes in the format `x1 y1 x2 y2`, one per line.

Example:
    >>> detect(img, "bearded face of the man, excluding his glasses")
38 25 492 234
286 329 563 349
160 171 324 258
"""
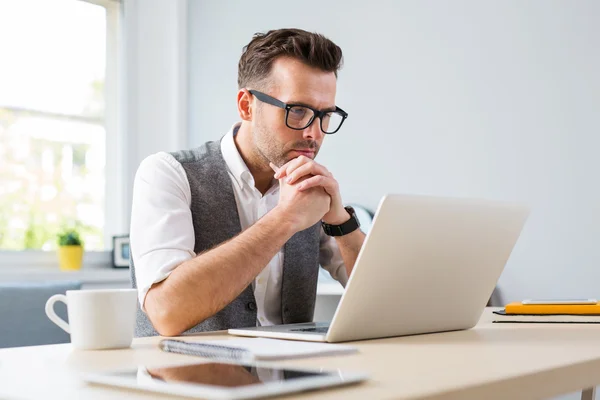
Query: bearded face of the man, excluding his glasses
252 57 337 166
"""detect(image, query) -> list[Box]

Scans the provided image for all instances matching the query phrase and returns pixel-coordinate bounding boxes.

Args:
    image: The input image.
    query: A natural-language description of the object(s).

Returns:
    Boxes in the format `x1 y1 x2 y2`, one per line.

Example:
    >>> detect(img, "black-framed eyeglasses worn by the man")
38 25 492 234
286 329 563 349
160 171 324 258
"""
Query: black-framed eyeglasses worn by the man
249 90 348 135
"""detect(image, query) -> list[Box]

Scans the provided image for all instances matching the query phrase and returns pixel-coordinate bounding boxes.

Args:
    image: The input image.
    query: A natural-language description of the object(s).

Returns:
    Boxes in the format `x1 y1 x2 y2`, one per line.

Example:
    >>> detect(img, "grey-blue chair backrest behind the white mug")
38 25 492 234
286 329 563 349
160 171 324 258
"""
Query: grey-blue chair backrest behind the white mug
0 281 81 348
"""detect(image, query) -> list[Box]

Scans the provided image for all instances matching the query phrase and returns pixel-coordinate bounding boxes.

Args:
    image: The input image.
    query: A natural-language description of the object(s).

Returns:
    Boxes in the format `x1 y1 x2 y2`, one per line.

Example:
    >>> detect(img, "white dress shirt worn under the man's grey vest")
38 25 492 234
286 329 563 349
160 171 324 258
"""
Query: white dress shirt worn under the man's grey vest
130 124 348 325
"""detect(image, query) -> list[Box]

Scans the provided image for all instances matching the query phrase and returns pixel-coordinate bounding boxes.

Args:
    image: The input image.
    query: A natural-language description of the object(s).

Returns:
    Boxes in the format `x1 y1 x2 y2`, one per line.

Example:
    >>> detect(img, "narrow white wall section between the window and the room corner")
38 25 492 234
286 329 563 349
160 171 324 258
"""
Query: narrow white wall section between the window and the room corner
122 0 188 225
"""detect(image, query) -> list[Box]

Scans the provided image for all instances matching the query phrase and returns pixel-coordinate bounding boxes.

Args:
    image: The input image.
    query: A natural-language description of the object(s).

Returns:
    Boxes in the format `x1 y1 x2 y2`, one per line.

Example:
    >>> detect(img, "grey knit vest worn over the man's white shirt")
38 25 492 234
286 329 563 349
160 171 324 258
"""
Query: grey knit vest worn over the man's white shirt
129 142 321 336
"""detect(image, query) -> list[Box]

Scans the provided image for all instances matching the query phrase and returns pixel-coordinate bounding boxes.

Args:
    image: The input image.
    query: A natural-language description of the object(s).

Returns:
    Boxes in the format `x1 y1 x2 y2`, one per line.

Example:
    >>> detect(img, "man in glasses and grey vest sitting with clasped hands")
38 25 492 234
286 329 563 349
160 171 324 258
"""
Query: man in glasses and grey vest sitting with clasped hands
131 29 364 336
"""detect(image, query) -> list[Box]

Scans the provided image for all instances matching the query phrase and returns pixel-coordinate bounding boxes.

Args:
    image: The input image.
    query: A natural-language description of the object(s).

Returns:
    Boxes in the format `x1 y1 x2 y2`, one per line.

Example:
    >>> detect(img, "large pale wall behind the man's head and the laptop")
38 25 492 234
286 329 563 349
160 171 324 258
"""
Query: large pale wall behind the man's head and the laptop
188 0 600 310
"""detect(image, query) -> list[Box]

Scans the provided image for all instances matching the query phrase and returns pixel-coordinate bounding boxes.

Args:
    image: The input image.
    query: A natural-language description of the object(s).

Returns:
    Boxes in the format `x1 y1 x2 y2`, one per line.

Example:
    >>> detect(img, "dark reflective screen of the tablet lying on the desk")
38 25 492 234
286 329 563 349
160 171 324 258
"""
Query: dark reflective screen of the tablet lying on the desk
111 362 331 388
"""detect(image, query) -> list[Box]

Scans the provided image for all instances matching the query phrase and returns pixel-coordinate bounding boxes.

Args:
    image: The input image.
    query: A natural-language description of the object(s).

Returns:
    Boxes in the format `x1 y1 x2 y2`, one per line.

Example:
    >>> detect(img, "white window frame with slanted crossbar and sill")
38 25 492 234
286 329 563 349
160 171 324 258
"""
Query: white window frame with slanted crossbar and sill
0 0 122 273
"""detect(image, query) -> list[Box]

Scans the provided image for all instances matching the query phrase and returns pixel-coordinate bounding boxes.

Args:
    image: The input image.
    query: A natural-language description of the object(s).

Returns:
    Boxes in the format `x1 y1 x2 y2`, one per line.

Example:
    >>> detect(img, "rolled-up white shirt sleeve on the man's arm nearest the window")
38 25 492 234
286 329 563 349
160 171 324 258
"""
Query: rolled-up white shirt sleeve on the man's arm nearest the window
130 152 195 310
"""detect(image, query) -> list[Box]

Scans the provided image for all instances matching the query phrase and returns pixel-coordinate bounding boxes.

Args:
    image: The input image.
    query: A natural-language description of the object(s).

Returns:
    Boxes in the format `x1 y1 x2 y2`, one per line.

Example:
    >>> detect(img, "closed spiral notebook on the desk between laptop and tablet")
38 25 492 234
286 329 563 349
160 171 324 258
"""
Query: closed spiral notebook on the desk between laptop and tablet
159 338 357 362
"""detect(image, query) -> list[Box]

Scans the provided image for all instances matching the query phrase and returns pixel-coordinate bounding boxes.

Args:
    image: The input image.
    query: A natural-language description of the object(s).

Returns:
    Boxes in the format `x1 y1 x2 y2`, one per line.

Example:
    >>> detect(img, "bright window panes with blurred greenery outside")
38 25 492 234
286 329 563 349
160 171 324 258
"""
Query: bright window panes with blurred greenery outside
0 0 119 250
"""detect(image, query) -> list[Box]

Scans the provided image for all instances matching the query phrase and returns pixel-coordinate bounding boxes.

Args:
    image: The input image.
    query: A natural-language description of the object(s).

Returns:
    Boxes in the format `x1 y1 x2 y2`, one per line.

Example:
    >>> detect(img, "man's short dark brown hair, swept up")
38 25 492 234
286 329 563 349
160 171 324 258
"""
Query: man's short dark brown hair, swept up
238 29 342 89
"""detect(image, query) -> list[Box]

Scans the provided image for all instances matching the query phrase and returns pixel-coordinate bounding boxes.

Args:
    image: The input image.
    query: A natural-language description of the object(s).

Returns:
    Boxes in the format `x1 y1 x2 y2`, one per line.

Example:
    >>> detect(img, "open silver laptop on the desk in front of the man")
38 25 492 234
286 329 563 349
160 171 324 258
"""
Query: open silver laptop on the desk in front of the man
228 194 529 343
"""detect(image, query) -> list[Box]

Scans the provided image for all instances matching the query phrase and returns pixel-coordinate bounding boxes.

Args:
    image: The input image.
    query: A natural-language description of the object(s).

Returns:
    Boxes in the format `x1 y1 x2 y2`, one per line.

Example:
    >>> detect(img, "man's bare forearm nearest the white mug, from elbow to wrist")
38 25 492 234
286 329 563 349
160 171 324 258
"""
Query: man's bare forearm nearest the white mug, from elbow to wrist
144 208 295 336
